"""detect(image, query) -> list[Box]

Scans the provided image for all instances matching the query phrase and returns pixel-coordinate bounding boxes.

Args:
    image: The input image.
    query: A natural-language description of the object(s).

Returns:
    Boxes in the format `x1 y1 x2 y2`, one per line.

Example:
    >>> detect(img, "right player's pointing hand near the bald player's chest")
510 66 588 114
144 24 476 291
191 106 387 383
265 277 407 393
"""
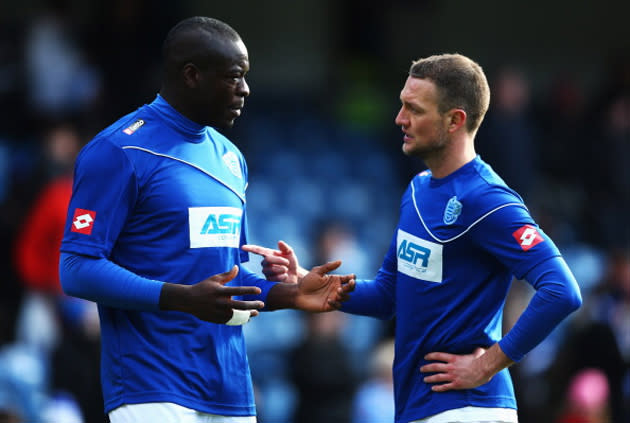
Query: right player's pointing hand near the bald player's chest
241 241 307 283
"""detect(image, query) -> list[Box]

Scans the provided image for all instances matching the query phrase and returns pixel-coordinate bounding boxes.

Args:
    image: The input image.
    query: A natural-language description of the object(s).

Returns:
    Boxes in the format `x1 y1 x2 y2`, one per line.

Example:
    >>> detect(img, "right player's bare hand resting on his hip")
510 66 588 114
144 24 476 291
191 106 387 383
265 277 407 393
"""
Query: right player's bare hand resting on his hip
420 348 494 392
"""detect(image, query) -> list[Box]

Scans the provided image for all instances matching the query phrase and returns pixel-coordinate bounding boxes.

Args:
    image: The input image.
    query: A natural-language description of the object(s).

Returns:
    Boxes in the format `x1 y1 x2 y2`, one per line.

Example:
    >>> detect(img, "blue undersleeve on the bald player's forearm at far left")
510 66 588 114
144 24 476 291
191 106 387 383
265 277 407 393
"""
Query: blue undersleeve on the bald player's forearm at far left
59 253 165 311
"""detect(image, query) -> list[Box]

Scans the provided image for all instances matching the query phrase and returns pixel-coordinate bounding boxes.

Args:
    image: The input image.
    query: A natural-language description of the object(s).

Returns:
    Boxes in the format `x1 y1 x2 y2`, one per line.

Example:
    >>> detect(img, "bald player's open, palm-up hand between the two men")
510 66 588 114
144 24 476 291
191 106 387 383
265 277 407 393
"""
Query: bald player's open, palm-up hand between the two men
295 260 355 312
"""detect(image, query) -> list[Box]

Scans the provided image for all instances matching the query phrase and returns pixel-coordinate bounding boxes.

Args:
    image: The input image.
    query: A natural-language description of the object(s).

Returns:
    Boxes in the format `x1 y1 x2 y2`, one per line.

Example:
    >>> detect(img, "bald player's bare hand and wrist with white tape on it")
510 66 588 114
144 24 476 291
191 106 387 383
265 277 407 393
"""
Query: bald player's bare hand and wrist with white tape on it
160 266 265 324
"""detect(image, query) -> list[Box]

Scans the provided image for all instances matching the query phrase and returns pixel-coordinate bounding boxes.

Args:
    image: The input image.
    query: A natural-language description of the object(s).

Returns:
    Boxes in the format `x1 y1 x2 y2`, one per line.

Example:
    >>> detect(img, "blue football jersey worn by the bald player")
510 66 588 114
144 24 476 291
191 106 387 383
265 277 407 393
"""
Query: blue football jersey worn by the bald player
61 96 255 416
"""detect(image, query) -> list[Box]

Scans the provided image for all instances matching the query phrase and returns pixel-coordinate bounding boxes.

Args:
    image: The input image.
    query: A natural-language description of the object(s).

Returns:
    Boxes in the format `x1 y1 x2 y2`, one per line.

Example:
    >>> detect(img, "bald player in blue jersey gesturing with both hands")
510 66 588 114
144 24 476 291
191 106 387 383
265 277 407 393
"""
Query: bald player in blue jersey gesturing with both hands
60 17 354 423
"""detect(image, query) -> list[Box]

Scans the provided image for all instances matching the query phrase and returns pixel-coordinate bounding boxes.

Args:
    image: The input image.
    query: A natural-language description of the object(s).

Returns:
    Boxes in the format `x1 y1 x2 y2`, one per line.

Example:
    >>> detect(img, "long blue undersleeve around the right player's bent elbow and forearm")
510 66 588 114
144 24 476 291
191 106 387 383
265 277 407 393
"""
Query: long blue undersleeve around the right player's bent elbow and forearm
499 257 582 361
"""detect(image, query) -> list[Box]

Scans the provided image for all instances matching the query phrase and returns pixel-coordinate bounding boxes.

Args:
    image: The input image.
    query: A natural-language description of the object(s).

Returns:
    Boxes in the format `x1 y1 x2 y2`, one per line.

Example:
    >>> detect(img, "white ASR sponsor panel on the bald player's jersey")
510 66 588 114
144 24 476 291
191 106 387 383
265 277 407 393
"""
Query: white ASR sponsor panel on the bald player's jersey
188 207 243 248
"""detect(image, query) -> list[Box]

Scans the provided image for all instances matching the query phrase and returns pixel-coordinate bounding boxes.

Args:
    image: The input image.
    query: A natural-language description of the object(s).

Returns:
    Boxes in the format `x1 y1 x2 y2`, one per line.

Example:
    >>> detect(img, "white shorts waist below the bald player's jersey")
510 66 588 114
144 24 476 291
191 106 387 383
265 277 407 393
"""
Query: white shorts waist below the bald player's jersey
109 402 256 423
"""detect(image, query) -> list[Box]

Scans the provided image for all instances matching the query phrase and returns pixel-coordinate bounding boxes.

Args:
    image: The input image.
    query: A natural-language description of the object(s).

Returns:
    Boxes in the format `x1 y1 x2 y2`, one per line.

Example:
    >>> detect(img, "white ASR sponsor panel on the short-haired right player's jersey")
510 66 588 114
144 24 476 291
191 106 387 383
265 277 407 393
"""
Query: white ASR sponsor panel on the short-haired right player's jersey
396 229 443 283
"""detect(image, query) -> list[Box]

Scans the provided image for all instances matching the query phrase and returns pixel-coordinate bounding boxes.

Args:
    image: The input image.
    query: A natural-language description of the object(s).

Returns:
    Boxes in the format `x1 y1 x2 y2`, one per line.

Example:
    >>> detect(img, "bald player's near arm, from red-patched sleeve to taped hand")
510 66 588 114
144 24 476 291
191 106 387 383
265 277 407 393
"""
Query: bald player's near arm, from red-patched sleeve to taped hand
59 138 263 323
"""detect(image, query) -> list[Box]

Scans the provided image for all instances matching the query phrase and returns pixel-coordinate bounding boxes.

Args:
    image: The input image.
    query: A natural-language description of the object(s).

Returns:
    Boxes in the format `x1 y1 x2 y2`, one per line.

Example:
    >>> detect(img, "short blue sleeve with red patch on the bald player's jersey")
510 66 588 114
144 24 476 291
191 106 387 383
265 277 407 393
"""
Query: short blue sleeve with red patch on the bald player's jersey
61 138 138 257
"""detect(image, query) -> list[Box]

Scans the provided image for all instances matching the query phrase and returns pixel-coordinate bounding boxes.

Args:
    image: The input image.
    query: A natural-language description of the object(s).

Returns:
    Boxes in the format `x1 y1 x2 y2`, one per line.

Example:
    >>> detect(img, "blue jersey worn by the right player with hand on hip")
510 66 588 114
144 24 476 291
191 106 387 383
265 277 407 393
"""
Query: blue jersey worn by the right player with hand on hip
379 157 560 422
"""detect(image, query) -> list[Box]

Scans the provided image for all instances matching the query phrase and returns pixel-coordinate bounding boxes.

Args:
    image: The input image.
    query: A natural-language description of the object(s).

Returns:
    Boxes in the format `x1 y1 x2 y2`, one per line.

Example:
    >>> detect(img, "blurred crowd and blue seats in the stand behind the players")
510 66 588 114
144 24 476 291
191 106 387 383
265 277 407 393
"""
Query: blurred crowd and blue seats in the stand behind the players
0 1 630 423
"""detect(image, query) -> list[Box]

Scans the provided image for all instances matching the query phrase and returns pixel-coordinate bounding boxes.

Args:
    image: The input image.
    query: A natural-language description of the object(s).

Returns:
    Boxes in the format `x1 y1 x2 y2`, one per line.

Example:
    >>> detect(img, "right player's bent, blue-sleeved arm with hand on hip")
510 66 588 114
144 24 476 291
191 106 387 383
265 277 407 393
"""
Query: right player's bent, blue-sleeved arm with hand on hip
420 207 582 392
